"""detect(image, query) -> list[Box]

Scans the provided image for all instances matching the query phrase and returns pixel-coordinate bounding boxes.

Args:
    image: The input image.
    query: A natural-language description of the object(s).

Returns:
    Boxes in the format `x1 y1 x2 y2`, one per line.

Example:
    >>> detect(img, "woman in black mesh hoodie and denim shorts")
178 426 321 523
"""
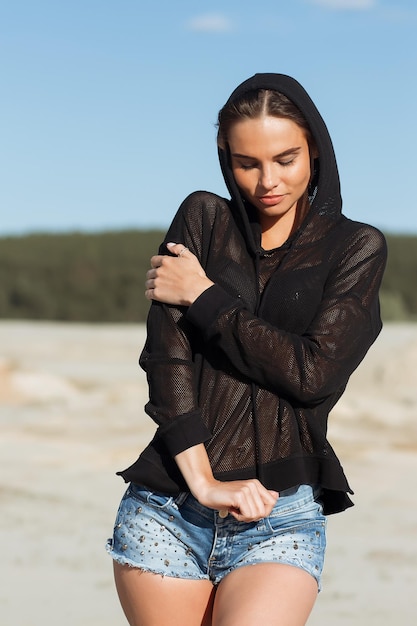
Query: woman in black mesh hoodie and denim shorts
108 74 386 626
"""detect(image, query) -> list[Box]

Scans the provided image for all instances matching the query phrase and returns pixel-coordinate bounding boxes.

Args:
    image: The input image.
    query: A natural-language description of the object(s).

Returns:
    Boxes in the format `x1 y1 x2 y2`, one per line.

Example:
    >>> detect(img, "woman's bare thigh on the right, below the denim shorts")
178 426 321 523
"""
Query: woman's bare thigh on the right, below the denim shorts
212 563 318 626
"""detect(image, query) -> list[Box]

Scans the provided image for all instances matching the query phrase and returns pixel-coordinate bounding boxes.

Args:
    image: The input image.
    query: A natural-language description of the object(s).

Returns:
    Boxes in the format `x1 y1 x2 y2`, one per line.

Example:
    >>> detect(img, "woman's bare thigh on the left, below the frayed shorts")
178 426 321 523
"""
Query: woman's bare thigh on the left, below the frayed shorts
114 561 214 626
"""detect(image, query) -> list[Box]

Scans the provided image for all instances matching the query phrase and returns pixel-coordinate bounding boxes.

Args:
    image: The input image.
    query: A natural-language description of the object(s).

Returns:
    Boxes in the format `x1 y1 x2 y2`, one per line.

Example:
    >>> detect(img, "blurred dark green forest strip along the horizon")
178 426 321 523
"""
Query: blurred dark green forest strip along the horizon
0 230 417 323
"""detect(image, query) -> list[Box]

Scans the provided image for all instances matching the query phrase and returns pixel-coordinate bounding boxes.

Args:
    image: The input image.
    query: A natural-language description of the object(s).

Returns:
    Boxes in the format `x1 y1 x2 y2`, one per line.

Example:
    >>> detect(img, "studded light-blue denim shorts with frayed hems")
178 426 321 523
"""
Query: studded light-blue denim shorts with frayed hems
107 483 326 590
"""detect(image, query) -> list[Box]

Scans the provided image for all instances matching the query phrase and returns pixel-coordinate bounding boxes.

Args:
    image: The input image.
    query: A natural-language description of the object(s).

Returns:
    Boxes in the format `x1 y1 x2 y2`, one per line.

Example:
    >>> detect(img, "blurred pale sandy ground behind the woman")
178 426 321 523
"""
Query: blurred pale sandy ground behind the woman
0 322 417 626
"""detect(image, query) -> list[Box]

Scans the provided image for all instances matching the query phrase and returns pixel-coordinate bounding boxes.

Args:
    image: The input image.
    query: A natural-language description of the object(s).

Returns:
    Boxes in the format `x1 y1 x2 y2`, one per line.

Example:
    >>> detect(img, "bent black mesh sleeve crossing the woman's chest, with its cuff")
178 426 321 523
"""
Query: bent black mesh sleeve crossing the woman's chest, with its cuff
187 226 386 405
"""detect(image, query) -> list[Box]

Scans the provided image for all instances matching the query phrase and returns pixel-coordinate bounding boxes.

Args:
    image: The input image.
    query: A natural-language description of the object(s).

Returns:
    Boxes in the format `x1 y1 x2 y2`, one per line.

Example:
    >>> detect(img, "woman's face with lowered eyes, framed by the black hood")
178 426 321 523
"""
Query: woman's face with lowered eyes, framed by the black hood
228 116 310 227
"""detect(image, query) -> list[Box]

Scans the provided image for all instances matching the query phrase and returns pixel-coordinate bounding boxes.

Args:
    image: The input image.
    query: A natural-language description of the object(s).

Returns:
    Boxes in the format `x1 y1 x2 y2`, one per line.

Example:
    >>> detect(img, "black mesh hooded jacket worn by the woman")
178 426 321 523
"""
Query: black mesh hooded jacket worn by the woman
119 74 386 514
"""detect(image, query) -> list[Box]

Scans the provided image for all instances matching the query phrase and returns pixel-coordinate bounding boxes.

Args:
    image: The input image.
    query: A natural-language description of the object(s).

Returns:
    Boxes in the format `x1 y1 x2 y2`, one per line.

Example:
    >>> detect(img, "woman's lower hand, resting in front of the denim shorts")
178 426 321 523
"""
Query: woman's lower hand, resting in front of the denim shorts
194 479 279 522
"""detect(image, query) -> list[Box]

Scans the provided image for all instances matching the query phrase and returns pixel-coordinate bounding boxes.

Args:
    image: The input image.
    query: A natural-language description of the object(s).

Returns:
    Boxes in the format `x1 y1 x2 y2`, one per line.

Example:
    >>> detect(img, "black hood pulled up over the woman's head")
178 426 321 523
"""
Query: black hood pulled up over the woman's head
219 74 342 251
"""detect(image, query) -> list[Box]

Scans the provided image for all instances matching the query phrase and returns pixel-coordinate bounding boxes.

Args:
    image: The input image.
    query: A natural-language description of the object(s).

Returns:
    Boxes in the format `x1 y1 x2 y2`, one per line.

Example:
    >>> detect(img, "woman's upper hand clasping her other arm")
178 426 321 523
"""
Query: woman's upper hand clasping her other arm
145 243 214 306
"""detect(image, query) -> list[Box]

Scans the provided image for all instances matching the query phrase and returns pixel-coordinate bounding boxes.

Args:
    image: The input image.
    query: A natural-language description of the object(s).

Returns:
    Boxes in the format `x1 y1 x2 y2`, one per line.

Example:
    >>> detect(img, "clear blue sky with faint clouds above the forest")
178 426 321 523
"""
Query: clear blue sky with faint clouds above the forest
0 0 417 235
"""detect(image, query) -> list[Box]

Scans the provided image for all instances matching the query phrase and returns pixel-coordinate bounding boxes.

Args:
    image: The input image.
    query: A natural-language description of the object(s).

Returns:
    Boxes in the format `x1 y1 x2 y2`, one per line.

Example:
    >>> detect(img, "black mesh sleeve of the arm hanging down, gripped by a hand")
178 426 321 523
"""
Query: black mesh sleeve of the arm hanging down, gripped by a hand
139 192 219 456
